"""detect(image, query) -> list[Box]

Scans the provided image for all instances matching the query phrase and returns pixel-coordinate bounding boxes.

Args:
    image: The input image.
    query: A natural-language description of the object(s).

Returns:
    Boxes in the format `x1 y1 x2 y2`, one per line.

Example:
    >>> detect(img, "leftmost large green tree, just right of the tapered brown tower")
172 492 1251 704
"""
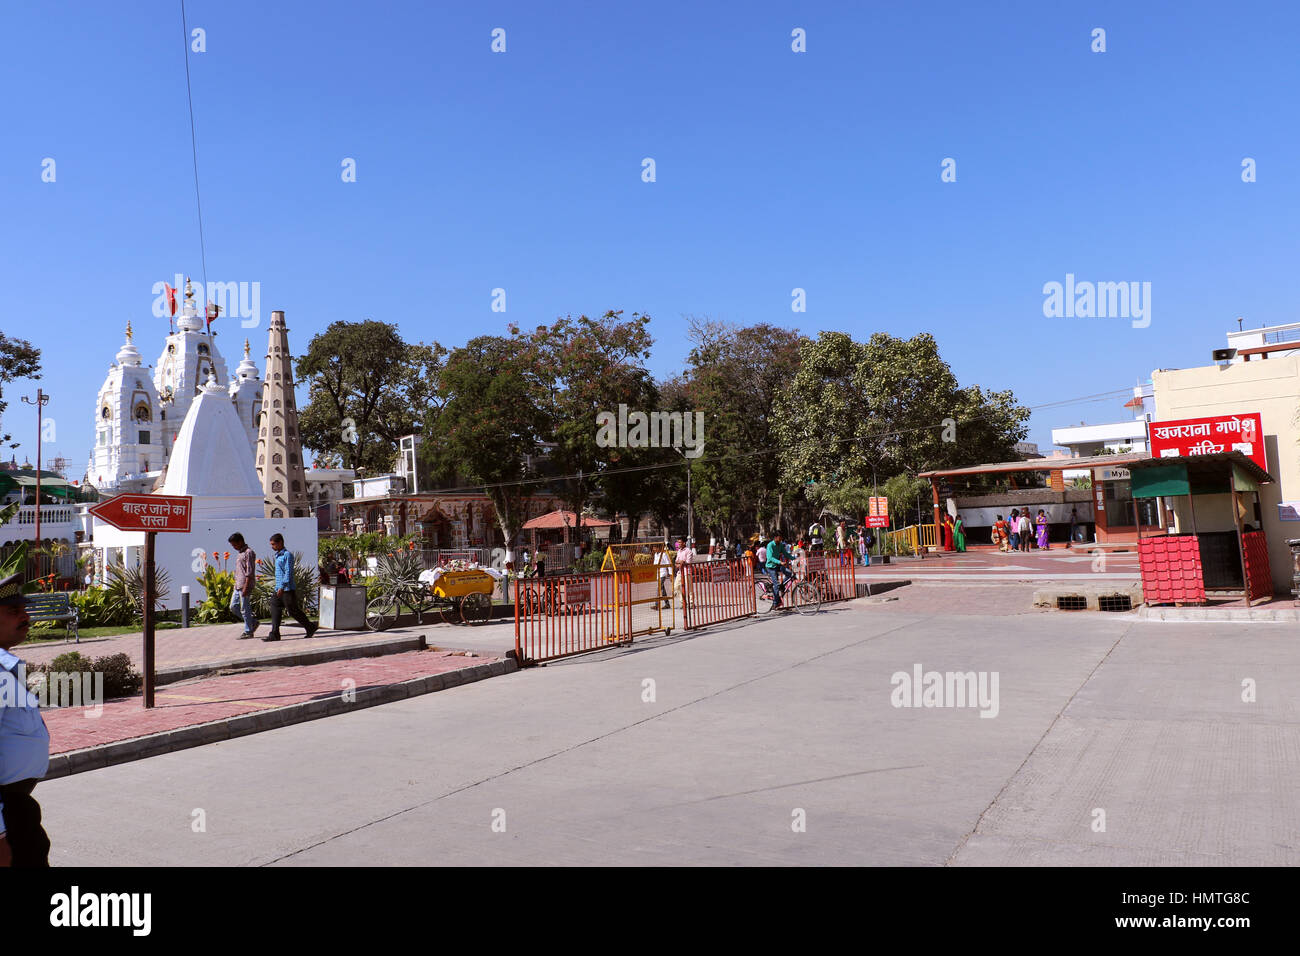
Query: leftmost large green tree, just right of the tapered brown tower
298 320 446 473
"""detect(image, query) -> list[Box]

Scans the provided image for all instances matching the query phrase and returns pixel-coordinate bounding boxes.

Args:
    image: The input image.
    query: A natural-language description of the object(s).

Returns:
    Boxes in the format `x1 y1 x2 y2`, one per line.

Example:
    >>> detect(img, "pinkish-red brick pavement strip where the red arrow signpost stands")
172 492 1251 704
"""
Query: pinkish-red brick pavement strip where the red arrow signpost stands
43 641 499 753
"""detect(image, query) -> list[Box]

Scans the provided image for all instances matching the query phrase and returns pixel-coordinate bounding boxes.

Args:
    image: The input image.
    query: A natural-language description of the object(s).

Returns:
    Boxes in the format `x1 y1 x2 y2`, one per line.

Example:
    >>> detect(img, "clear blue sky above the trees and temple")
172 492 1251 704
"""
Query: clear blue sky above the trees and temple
0 0 1300 477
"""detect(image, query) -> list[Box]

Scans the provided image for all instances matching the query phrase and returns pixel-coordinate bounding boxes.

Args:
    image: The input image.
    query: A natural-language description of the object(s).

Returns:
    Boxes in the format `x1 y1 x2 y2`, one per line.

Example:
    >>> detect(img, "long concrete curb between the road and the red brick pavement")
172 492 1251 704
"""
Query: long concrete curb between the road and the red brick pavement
44 657 519 780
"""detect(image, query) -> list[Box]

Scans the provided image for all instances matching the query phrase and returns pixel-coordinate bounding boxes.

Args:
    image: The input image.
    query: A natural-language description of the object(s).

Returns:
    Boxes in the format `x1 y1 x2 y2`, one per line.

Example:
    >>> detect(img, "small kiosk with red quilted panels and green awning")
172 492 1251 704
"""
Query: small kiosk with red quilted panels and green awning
1128 450 1273 607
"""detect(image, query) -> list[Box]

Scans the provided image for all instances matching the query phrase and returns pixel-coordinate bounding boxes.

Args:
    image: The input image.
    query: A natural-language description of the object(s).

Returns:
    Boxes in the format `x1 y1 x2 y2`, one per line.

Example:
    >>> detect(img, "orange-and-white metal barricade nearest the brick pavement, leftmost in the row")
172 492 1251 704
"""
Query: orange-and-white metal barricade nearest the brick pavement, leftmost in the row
515 571 632 665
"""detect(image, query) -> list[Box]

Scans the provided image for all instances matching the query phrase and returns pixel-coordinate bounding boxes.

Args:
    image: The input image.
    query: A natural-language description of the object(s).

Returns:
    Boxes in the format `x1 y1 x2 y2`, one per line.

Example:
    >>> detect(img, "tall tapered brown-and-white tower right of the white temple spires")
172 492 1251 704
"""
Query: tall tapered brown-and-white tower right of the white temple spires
257 312 312 518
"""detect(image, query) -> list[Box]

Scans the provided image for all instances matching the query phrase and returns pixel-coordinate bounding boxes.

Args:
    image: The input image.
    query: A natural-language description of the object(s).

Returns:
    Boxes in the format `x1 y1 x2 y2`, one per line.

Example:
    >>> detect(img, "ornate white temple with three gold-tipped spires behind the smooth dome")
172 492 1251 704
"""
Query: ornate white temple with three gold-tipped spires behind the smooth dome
86 281 263 494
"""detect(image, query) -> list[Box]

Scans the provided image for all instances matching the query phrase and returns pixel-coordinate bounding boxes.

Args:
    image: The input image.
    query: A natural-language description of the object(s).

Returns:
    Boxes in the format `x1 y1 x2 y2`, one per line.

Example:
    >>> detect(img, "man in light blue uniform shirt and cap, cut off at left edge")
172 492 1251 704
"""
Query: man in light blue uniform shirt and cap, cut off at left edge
0 574 49 866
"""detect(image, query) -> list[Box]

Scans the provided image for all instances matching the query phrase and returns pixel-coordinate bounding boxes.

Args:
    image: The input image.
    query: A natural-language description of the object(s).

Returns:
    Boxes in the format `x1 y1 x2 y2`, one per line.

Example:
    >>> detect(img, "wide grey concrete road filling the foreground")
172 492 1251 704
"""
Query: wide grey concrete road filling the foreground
36 600 1300 865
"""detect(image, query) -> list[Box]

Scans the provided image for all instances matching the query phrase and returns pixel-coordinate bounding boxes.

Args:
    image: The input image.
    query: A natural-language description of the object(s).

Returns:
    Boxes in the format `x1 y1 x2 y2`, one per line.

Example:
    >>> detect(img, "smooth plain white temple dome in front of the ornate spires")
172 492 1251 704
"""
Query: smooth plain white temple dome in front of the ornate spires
161 373 265 518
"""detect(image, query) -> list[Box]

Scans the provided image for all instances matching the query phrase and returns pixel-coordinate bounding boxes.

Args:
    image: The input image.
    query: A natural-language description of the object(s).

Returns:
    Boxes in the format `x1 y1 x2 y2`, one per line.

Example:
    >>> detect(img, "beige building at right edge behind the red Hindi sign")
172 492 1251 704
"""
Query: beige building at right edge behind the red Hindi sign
1152 351 1300 594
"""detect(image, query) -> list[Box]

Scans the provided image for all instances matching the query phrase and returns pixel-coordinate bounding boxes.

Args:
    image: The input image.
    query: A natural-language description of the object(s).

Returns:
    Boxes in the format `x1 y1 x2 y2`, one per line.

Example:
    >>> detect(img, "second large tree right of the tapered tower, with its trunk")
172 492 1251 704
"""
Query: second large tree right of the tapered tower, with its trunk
420 336 550 545
